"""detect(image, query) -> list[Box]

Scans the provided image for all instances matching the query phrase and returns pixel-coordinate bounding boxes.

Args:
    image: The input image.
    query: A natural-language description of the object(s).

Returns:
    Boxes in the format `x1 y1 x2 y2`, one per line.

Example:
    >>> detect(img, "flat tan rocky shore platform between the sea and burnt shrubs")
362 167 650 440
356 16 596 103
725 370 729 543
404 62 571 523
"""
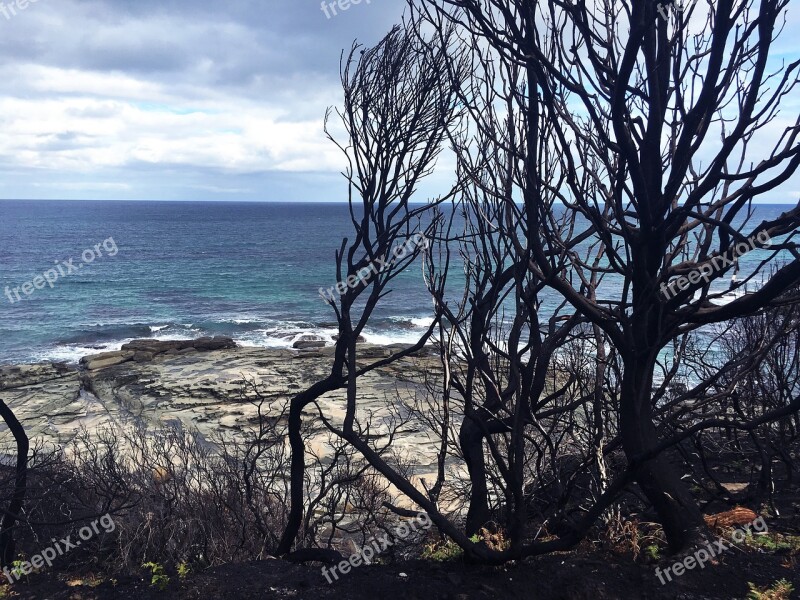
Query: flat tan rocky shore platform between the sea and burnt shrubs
0 337 444 473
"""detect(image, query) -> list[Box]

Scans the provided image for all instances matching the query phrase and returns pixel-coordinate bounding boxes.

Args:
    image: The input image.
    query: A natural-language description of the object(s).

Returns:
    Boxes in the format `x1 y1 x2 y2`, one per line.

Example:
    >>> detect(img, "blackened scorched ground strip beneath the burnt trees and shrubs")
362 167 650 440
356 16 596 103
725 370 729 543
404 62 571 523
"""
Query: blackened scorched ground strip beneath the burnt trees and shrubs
0 528 800 600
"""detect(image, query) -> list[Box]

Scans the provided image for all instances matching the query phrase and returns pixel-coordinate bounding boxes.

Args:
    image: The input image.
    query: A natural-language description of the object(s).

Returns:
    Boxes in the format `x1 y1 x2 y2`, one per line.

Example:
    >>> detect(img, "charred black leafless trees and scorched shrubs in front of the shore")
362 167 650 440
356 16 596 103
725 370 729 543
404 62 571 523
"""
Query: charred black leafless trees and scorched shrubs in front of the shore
0 0 800 592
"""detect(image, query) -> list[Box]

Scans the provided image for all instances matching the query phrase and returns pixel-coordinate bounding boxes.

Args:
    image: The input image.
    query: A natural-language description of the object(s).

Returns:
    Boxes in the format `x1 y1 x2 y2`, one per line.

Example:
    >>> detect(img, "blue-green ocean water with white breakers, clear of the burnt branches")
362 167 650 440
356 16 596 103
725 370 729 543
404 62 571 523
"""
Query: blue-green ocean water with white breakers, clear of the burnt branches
0 201 786 364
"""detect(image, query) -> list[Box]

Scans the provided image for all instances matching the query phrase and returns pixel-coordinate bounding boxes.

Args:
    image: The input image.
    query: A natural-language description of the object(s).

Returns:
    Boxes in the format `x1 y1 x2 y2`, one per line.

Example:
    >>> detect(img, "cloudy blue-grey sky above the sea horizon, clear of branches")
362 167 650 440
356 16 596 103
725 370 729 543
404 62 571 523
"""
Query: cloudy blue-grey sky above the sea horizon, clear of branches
0 0 800 202
